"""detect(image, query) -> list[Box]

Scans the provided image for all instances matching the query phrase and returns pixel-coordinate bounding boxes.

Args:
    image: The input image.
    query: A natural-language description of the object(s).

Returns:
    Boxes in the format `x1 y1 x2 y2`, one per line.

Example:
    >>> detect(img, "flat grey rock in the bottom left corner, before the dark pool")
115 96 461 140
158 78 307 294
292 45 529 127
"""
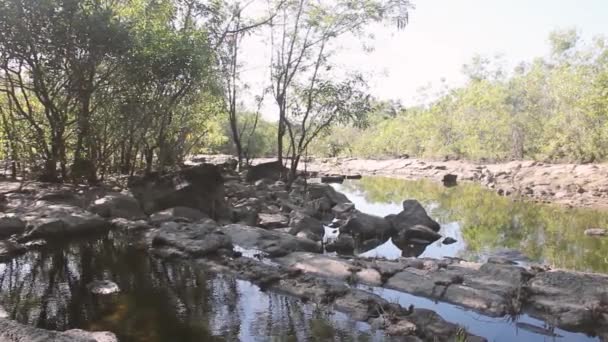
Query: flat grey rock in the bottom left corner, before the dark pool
0 319 118 342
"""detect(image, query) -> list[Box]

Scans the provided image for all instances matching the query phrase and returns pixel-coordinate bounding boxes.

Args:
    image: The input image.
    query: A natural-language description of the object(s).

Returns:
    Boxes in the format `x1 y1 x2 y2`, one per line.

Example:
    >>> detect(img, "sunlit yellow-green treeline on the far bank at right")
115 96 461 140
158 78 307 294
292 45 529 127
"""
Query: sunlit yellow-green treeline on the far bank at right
311 30 608 162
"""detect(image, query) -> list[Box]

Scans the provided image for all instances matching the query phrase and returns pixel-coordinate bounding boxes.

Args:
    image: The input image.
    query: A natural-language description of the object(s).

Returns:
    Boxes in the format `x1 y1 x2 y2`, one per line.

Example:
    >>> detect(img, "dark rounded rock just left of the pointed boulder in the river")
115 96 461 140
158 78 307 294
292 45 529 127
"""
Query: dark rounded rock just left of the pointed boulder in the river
340 210 393 240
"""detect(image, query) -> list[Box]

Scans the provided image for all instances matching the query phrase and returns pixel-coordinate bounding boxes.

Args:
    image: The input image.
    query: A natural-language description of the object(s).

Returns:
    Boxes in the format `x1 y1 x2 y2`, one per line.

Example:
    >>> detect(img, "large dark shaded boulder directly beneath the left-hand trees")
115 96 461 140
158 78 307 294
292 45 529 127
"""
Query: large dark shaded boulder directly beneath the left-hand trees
129 164 229 218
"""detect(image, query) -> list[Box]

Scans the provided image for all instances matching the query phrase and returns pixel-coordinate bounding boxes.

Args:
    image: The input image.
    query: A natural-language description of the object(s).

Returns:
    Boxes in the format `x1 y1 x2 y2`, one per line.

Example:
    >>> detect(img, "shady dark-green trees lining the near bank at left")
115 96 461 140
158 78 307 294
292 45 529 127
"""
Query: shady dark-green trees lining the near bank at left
0 0 410 183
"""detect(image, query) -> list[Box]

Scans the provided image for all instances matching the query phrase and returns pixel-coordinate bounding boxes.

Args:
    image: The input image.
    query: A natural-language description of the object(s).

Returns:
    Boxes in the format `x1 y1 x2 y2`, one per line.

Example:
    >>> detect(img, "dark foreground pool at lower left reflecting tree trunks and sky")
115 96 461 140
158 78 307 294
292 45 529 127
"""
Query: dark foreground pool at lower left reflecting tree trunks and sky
0 236 382 342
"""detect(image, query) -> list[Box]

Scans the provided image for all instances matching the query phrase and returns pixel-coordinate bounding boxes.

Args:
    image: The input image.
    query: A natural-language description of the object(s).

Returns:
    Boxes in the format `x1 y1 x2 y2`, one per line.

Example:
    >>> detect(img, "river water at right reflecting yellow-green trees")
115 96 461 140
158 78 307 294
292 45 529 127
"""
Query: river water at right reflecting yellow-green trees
335 177 608 273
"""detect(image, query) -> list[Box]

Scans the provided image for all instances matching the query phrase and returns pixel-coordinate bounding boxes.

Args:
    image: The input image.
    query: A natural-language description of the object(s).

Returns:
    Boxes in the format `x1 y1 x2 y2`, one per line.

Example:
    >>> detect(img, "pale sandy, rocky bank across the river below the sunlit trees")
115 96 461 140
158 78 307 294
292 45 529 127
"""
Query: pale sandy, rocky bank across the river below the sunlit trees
292 158 608 209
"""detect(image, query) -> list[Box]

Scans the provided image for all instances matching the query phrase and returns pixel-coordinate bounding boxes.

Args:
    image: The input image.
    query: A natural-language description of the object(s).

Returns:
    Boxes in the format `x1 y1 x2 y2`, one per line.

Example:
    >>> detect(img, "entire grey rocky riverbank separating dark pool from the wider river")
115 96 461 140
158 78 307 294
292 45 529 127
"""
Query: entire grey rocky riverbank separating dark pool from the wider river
0 163 608 341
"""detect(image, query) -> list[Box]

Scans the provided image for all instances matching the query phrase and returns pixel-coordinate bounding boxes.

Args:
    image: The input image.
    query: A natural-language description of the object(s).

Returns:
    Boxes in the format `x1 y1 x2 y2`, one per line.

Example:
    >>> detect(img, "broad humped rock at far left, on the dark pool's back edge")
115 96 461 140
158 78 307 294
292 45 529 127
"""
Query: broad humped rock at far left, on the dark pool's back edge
23 204 107 241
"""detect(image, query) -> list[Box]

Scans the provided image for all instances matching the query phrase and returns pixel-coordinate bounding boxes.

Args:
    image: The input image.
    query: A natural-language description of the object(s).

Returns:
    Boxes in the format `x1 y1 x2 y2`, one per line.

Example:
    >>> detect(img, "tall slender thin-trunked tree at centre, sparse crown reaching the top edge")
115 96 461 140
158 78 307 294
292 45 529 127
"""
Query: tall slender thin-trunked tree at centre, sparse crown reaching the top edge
270 0 411 173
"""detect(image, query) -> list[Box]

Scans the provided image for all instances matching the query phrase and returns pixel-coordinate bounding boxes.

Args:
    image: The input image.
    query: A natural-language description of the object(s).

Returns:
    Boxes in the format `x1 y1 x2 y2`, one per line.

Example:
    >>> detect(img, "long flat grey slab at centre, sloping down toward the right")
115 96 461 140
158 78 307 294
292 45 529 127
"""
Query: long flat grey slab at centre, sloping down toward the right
222 224 323 257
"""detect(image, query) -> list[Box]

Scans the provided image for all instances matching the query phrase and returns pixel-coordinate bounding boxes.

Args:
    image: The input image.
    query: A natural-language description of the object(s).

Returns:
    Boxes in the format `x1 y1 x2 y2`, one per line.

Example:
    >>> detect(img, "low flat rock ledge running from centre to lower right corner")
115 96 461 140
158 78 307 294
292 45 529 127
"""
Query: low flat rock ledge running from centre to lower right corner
151 221 608 341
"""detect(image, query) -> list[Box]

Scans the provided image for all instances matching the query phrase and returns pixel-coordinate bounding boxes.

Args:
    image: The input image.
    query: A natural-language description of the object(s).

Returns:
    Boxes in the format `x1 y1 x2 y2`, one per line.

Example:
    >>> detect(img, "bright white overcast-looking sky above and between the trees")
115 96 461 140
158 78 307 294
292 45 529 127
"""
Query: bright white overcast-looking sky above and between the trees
238 0 608 117
